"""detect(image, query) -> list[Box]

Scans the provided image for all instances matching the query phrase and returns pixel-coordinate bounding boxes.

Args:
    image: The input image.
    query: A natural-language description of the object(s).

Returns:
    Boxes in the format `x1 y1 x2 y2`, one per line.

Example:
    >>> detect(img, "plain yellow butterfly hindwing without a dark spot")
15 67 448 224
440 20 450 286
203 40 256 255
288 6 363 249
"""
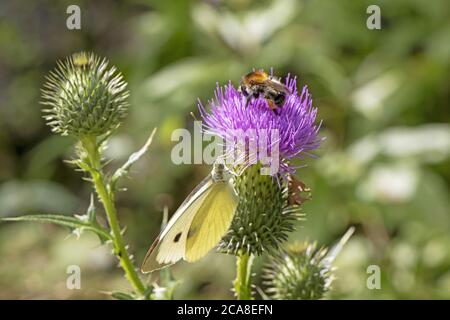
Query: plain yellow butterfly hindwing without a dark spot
184 182 238 262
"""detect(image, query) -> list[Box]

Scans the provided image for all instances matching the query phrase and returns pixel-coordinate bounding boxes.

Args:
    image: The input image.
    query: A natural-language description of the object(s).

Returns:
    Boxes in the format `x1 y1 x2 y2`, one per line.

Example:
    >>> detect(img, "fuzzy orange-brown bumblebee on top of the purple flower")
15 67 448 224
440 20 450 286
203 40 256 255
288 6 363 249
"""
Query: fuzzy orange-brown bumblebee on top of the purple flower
239 70 290 113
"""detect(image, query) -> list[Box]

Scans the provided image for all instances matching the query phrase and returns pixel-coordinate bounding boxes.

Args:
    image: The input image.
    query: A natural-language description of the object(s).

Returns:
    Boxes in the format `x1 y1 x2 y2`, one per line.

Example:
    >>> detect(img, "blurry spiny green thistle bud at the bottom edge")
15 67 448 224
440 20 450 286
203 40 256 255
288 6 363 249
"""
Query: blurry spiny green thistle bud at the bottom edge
263 242 332 300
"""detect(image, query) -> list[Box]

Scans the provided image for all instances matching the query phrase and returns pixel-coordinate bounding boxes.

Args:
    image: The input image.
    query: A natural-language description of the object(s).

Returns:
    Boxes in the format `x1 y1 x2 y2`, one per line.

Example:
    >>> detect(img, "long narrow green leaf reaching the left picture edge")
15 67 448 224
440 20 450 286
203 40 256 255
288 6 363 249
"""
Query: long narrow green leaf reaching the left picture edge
1 214 111 242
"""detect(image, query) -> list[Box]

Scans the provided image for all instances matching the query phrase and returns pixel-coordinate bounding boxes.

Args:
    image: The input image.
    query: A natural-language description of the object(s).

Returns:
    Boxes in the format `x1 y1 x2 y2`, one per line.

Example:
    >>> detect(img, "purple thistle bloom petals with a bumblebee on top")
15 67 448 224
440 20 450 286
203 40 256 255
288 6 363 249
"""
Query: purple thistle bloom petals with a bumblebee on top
199 75 323 177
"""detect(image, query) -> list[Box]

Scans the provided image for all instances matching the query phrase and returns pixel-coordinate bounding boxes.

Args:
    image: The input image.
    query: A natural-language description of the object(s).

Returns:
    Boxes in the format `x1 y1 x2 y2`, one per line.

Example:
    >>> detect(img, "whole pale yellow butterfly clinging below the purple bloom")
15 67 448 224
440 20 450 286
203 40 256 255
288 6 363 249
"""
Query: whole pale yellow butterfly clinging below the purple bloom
141 162 238 273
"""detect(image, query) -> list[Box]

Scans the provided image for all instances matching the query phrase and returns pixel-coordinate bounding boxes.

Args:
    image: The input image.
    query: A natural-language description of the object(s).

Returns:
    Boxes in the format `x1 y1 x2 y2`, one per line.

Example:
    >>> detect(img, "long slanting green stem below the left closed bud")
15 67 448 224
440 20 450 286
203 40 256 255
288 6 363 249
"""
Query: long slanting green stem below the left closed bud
81 136 145 295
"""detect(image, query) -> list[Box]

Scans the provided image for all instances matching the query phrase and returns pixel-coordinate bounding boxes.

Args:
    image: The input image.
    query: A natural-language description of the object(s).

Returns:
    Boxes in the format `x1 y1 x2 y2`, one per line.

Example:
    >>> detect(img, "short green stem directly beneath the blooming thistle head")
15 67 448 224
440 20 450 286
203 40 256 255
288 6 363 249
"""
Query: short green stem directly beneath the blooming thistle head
233 253 254 300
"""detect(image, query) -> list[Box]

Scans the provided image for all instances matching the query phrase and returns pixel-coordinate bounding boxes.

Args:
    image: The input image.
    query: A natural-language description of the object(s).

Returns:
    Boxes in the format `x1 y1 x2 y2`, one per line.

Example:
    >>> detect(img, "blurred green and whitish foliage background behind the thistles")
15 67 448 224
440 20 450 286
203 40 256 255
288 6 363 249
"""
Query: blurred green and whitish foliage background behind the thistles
0 0 450 299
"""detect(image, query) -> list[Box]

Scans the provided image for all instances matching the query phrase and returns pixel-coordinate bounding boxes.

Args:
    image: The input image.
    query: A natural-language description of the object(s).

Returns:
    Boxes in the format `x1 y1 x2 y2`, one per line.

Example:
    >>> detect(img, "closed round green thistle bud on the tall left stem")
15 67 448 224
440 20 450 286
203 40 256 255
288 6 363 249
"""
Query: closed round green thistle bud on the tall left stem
42 52 128 137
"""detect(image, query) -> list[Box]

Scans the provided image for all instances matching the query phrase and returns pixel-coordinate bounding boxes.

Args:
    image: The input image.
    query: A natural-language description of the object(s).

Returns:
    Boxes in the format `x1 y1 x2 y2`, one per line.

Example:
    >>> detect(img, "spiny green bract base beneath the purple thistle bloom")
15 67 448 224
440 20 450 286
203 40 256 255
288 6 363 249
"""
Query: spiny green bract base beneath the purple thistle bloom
219 164 301 255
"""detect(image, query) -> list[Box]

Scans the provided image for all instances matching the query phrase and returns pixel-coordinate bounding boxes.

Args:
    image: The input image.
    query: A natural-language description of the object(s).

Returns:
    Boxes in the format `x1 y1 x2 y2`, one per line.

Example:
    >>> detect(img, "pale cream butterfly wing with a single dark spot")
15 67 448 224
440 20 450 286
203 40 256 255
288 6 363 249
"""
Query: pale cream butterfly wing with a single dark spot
141 176 214 273
